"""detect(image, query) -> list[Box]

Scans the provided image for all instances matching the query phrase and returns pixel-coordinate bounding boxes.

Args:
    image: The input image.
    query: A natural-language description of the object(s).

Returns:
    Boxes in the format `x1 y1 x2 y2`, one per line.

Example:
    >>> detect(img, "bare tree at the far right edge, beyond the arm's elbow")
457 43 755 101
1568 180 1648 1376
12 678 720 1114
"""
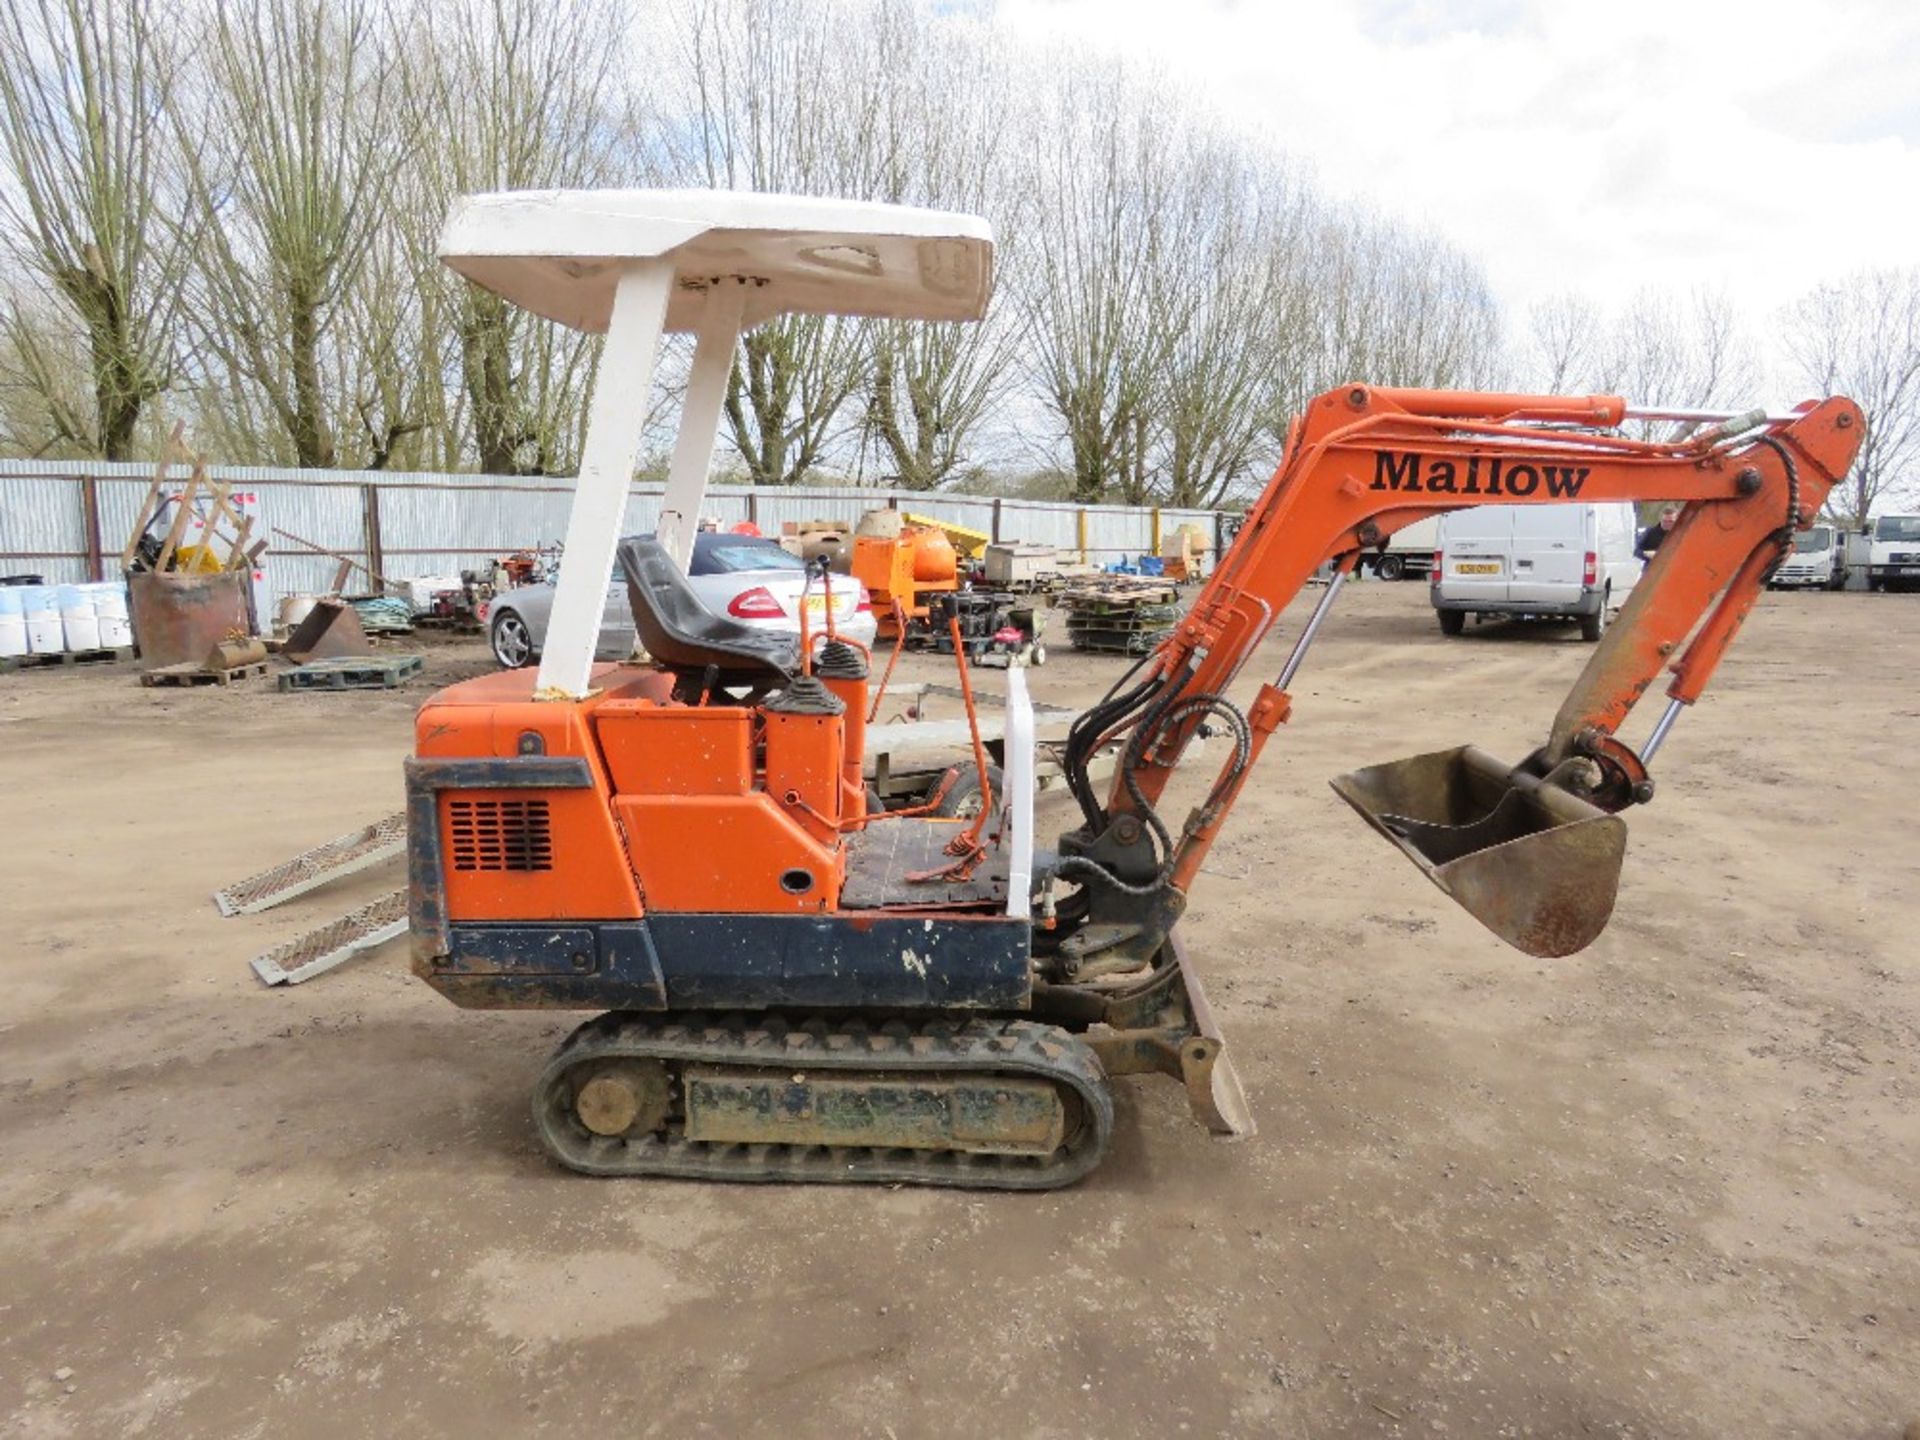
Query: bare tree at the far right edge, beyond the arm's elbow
1784 269 1920 526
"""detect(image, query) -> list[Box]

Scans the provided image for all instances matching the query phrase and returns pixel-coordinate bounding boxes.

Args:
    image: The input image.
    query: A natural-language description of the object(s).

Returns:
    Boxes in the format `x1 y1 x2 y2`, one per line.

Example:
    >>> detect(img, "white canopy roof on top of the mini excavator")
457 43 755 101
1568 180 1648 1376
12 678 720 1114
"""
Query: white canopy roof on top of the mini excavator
440 190 993 332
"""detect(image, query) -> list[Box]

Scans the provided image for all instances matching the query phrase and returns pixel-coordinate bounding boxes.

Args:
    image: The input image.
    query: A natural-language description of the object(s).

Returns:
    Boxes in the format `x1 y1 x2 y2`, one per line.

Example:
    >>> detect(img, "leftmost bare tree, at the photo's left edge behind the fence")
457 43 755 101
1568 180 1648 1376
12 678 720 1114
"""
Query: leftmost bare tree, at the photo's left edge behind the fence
0 0 188 459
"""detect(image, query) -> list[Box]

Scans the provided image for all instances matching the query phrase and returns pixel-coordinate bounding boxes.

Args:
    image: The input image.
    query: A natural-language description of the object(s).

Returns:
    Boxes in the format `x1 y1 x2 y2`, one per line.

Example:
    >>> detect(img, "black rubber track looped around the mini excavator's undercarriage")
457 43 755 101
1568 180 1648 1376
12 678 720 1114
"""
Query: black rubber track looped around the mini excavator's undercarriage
534 1012 1114 1190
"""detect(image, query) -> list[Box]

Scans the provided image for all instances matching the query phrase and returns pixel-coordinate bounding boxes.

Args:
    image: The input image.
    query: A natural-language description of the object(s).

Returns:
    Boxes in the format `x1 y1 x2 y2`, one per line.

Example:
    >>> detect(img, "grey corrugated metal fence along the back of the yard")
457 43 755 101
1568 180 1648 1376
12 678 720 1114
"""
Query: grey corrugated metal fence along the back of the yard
0 461 1219 601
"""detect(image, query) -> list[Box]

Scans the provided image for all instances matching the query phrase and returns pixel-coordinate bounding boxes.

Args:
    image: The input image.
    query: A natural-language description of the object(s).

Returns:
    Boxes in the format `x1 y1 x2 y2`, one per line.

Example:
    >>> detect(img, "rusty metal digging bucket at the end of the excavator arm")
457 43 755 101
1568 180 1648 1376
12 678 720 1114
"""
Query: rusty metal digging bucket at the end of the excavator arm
1332 745 1626 958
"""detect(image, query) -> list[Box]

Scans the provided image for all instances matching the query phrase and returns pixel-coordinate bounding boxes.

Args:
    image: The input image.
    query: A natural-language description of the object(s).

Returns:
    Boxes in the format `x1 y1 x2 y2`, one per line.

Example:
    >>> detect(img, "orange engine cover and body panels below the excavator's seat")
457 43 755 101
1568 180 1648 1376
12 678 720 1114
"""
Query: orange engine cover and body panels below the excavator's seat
415 666 847 920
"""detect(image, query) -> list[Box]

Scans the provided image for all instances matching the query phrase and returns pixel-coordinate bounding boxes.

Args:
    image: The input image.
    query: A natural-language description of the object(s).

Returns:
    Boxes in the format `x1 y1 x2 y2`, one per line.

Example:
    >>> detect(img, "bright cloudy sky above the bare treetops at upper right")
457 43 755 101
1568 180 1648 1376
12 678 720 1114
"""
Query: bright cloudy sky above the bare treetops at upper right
993 0 1920 323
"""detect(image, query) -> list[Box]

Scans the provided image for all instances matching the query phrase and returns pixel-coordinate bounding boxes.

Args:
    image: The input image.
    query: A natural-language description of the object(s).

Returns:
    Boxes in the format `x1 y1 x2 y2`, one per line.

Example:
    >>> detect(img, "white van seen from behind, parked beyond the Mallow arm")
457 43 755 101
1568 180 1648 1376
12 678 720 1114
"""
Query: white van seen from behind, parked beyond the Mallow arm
1432 501 1640 639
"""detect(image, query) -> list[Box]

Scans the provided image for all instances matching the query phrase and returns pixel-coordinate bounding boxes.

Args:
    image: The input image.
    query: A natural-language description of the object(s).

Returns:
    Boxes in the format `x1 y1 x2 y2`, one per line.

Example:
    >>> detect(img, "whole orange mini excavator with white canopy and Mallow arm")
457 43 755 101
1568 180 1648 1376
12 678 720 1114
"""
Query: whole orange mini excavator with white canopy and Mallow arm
407 192 1862 1188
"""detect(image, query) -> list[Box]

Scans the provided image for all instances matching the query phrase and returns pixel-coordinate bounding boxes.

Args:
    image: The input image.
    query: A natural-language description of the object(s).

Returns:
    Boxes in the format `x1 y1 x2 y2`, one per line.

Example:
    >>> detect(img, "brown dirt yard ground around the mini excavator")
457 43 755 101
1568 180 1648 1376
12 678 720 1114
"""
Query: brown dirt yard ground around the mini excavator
0 584 1920 1440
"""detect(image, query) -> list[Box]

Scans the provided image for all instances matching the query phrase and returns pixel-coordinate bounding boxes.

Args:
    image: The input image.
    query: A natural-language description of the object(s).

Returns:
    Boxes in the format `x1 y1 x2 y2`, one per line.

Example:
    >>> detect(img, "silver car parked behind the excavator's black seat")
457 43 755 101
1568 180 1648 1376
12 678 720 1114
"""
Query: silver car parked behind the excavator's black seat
484 532 874 670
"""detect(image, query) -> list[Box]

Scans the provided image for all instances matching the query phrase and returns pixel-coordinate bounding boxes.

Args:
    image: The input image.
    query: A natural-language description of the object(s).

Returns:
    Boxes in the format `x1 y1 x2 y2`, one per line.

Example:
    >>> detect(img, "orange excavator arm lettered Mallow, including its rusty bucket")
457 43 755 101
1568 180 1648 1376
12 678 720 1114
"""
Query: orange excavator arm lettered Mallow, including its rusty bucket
1052 386 1864 981
